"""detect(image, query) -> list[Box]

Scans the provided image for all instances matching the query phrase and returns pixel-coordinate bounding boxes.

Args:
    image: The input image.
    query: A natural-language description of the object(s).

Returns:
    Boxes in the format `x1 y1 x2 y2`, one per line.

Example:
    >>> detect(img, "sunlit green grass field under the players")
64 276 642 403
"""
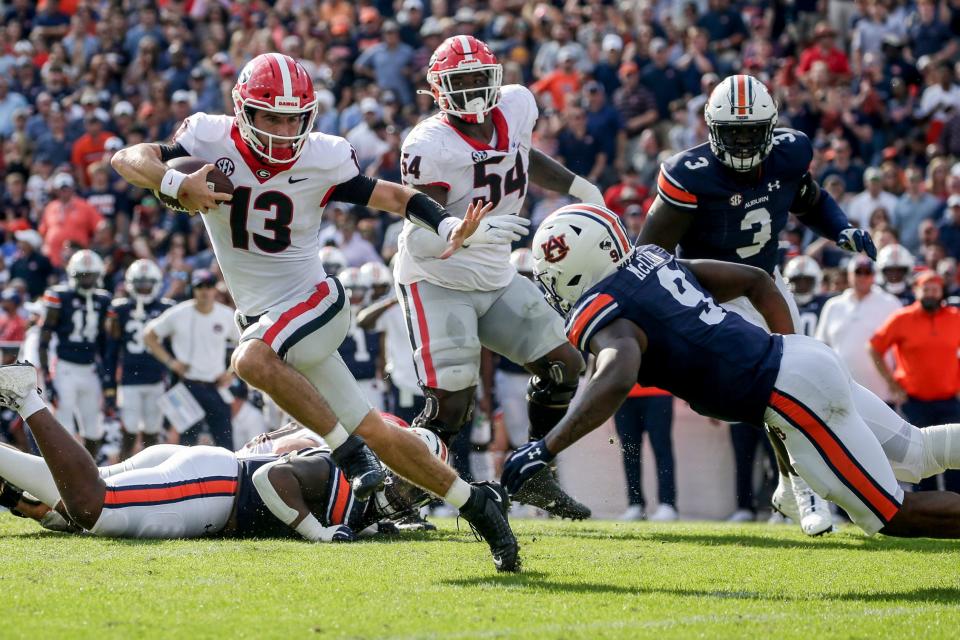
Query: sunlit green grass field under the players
0 515 960 640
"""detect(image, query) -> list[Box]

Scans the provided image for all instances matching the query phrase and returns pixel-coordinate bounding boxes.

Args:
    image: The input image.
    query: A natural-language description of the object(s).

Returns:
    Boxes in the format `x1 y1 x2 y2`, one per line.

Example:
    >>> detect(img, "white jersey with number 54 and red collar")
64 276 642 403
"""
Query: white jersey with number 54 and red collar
394 84 538 291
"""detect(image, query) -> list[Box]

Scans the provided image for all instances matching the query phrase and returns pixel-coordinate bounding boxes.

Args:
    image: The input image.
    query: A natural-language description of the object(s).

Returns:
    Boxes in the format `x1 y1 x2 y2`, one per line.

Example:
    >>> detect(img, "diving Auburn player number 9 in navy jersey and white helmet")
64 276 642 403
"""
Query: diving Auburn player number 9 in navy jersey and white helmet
503 204 960 538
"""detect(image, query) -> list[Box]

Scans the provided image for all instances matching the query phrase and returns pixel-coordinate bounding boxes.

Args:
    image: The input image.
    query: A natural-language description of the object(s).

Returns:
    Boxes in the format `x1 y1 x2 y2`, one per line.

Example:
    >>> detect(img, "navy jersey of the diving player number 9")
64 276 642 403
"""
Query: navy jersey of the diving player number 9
566 245 783 424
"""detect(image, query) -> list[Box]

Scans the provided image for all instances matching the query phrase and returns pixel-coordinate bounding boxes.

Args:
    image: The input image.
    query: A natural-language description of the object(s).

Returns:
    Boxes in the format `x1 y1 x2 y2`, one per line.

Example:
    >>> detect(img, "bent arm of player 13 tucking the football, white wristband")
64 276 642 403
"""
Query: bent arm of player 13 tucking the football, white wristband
110 142 233 211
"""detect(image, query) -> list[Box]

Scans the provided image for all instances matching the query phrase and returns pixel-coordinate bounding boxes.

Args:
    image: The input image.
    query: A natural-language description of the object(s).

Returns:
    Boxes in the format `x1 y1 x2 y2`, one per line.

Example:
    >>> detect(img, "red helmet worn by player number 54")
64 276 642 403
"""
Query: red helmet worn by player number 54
427 36 503 122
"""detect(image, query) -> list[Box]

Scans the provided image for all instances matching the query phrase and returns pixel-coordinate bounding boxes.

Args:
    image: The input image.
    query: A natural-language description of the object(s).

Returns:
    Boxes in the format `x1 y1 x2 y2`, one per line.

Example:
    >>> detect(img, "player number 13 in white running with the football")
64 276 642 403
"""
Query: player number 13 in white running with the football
112 53 526 570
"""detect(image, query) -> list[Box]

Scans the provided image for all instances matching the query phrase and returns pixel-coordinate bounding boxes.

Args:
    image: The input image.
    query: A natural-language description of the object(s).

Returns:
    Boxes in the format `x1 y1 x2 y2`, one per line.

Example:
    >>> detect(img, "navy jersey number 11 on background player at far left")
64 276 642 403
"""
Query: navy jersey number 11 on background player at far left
43 284 110 364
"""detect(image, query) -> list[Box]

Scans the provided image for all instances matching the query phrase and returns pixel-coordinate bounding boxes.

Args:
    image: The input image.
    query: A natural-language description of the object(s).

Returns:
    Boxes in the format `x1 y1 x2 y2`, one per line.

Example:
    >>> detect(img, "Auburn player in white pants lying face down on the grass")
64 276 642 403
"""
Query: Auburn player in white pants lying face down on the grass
0 400 446 542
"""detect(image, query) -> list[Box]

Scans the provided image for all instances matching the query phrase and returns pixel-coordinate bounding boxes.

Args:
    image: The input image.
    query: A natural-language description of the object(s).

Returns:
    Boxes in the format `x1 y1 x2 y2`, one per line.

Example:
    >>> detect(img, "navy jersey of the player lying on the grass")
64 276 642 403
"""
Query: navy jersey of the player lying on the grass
234 449 375 538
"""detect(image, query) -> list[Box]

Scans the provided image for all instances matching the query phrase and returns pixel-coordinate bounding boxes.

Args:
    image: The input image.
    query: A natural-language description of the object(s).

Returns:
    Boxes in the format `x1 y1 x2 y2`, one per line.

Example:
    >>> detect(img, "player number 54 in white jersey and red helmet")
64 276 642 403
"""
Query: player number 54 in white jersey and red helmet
394 36 603 518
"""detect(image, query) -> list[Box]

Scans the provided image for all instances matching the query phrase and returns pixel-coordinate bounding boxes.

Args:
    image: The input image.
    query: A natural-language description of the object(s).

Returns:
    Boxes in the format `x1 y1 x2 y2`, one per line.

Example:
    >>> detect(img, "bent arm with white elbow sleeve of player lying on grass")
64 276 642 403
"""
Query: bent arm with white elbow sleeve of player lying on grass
253 455 354 542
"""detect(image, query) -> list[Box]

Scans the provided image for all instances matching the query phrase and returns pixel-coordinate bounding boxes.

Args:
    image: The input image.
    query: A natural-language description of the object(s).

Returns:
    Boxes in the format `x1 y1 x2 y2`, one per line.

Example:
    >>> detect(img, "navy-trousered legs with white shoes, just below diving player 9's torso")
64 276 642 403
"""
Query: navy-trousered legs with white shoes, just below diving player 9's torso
613 385 678 521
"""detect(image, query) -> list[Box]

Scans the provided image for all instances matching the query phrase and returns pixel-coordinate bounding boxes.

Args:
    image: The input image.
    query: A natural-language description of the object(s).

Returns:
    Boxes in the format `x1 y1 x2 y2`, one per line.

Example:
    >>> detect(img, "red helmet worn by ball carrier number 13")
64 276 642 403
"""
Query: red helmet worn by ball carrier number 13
233 53 317 164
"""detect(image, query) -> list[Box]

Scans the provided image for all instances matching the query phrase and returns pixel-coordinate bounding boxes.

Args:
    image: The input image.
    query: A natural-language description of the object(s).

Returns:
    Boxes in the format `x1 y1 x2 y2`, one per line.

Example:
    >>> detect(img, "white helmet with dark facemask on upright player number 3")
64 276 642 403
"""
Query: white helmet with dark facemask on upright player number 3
703 74 777 171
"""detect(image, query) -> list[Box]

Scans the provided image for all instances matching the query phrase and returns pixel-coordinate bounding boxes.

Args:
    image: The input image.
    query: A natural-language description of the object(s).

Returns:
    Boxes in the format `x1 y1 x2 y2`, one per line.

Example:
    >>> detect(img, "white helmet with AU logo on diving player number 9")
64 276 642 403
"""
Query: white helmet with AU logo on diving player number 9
533 203 633 314
